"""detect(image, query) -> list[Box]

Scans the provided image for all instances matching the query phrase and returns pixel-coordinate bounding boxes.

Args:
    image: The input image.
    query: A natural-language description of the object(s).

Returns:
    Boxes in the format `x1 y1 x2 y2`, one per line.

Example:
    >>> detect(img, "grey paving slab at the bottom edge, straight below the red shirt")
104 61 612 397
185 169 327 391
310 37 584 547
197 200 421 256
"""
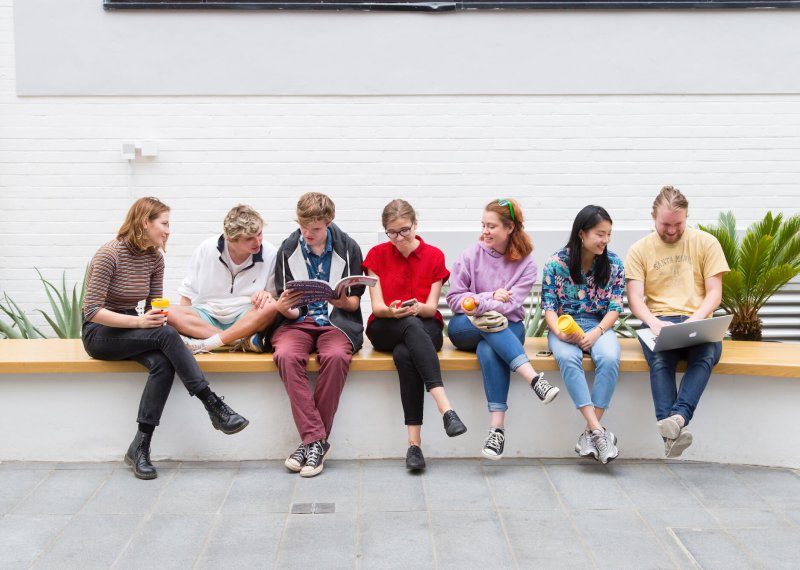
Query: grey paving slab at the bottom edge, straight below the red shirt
357 511 435 570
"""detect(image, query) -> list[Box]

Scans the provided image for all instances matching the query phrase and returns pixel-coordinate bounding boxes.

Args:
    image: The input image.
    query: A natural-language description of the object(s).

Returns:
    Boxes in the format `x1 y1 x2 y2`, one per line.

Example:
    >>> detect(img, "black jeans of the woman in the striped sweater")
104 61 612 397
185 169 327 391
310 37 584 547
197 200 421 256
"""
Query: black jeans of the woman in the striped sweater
83 323 208 426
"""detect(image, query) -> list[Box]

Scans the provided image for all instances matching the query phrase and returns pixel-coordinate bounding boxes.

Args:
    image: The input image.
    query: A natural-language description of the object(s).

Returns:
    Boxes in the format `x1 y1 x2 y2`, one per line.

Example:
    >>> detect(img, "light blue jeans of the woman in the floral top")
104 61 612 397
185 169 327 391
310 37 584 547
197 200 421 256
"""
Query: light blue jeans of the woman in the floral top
547 314 620 410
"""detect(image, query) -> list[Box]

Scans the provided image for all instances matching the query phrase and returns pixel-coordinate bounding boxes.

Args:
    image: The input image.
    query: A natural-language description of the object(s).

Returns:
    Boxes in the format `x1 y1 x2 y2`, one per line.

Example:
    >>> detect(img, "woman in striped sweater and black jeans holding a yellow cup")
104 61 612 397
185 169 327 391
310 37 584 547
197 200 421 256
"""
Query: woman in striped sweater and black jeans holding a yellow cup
83 198 249 479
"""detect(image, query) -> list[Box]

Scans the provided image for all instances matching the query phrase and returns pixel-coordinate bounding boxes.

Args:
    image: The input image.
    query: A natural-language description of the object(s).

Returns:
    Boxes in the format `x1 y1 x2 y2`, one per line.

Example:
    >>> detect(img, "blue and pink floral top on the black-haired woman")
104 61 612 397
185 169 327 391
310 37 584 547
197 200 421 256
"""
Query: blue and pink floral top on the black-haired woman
542 244 625 316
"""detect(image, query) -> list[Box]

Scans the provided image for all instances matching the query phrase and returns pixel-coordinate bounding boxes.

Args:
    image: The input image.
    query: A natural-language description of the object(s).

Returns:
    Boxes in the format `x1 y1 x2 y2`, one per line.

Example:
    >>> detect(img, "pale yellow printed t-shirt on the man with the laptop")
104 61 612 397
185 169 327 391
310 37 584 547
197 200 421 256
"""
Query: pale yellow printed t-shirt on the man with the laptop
625 228 730 316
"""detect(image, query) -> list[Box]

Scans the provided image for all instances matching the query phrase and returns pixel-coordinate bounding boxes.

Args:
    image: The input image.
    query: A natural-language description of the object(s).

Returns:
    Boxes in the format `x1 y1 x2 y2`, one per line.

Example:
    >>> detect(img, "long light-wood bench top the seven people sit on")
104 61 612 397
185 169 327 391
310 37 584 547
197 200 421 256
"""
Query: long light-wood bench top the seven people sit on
0 338 800 378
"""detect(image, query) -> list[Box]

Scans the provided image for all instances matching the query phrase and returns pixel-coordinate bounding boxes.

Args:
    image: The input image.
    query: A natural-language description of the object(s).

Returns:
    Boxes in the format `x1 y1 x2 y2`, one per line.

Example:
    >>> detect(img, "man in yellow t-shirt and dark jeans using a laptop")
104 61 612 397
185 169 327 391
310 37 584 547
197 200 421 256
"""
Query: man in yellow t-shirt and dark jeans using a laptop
625 186 730 457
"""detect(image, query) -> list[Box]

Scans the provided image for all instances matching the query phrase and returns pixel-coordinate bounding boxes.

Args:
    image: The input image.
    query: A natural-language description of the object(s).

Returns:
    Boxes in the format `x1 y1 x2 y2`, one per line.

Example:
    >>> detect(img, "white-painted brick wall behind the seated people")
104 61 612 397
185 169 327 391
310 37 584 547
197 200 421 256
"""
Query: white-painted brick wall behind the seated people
0 0 800 328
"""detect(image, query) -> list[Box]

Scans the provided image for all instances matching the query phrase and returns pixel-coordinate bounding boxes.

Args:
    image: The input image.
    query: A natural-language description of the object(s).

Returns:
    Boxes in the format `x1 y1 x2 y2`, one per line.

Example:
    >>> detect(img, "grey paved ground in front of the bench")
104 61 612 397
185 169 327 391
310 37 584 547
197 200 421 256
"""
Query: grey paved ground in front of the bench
0 458 800 570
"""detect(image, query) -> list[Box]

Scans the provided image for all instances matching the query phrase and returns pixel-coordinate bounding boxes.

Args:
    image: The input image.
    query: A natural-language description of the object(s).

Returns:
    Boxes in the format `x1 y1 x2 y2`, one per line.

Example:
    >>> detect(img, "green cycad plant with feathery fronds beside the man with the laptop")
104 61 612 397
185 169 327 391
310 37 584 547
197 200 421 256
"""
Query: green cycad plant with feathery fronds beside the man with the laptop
698 212 800 340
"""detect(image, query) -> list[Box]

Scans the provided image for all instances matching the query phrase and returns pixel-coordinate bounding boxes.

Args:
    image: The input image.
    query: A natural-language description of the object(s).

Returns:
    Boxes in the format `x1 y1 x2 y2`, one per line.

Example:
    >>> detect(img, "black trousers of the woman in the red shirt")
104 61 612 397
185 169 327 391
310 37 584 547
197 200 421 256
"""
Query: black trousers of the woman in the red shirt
367 317 444 426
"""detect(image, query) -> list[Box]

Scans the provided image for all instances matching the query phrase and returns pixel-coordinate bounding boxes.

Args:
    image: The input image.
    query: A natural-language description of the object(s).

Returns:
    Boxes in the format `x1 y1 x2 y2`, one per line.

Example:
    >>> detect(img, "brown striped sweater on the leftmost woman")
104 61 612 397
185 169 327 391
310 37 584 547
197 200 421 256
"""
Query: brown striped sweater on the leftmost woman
83 240 164 322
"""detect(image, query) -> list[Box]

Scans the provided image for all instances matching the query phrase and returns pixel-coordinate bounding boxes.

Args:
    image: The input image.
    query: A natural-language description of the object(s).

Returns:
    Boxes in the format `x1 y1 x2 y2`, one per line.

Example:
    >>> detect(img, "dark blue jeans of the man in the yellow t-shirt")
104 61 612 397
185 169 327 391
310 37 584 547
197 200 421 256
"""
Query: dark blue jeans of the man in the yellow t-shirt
639 316 722 425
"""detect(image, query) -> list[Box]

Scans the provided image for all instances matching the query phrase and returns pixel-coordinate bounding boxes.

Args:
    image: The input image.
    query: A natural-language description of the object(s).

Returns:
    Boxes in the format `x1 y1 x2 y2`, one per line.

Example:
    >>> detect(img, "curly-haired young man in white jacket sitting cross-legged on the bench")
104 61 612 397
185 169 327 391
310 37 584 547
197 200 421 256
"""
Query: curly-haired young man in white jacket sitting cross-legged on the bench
168 204 277 353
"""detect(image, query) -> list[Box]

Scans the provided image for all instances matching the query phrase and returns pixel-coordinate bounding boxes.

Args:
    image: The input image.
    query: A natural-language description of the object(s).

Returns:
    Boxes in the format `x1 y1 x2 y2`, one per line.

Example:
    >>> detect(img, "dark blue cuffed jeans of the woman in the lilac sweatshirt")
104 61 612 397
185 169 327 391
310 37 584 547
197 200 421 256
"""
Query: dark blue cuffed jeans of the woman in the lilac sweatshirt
447 314 530 412
